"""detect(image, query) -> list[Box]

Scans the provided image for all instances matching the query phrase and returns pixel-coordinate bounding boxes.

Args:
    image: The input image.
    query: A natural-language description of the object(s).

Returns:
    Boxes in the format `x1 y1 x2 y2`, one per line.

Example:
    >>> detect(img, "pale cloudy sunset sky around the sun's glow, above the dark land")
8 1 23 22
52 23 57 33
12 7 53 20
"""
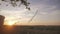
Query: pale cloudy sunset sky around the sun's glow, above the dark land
0 0 60 25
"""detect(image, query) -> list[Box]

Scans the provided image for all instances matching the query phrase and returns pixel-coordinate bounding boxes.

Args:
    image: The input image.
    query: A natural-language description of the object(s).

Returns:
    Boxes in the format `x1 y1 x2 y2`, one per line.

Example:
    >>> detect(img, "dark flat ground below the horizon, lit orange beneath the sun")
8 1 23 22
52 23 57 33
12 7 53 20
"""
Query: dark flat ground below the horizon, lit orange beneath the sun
0 25 60 34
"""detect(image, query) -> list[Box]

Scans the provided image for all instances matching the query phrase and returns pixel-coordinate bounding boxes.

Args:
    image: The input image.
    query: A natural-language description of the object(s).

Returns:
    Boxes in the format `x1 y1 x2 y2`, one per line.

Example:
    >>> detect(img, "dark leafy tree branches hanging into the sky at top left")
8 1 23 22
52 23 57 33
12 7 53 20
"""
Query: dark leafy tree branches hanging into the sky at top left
0 0 30 10
